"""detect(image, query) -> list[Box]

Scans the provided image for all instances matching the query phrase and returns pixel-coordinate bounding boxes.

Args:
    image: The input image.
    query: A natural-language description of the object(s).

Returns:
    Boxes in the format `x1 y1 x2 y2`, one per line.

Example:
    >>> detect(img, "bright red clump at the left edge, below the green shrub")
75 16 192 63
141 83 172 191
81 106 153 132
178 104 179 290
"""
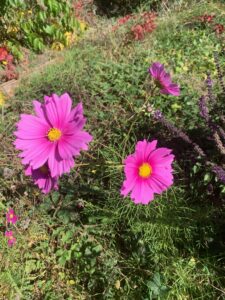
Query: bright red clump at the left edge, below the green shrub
0 47 18 81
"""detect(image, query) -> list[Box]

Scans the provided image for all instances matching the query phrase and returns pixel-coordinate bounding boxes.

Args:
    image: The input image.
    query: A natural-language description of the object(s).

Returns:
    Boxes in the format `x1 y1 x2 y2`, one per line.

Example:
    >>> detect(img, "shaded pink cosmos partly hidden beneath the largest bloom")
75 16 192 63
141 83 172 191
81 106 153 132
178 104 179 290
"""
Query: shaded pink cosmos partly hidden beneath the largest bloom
25 164 58 194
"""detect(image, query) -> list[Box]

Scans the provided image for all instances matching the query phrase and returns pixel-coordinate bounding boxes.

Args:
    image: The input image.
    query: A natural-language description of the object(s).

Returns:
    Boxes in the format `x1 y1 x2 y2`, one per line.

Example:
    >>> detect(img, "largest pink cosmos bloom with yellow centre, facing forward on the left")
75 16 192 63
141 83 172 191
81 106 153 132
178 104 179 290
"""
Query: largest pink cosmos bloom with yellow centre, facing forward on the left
14 93 92 177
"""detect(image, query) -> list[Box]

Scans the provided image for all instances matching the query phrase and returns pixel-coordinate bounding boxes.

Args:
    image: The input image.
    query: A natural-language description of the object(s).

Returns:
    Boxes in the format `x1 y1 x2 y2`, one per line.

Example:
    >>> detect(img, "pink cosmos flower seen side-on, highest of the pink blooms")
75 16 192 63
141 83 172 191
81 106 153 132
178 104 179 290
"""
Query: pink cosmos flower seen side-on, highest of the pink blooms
148 62 180 96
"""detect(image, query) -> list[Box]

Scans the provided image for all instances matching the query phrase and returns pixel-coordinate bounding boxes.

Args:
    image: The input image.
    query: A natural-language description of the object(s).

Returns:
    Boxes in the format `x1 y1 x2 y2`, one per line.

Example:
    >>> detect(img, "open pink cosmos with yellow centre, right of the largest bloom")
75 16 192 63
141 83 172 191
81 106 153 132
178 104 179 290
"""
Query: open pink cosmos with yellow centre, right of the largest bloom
121 140 174 204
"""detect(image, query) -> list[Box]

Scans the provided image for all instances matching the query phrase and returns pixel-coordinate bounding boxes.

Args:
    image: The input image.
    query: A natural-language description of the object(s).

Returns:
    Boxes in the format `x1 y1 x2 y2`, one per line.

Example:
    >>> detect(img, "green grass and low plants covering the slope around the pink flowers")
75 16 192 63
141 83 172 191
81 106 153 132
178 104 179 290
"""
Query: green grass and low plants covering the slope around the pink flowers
0 3 225 300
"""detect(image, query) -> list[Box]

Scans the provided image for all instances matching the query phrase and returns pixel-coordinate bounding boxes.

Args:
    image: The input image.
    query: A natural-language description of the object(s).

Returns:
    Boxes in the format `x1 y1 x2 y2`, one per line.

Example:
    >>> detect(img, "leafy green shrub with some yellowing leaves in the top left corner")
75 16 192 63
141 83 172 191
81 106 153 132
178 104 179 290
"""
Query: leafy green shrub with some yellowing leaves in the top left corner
0 0 79 58
